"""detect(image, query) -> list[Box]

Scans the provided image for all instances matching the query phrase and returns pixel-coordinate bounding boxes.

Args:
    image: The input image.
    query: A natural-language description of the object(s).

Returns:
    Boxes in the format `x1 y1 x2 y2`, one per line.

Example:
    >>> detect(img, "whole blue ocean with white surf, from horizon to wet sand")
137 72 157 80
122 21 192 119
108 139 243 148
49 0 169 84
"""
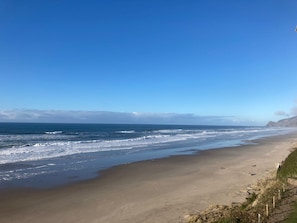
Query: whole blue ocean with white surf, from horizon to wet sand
0 123 291 189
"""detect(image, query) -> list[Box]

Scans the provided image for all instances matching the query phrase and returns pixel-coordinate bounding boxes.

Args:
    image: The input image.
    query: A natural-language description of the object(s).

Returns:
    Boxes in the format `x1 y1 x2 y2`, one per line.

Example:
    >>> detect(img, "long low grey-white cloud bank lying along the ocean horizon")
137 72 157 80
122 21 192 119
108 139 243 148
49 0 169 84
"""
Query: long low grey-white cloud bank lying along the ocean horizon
0 109 259 125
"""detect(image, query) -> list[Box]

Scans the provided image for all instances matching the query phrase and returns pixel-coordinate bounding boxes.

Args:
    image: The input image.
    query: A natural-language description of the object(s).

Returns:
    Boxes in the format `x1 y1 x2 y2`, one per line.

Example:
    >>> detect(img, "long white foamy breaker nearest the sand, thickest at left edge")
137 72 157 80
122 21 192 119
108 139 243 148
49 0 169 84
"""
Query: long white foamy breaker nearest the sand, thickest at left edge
0 134 208 164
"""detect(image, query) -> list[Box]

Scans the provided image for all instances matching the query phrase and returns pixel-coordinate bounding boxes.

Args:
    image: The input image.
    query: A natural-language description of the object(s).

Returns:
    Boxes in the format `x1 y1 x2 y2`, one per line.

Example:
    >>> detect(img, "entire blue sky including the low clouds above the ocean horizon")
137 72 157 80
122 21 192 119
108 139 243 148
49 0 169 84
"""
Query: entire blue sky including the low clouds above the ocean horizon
0 0 297 125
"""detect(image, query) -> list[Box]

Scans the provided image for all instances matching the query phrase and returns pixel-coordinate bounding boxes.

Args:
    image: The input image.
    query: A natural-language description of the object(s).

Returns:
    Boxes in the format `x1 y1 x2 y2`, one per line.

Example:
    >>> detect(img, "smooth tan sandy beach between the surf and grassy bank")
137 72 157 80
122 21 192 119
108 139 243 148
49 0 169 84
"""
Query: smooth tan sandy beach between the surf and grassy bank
0 134 297 223
